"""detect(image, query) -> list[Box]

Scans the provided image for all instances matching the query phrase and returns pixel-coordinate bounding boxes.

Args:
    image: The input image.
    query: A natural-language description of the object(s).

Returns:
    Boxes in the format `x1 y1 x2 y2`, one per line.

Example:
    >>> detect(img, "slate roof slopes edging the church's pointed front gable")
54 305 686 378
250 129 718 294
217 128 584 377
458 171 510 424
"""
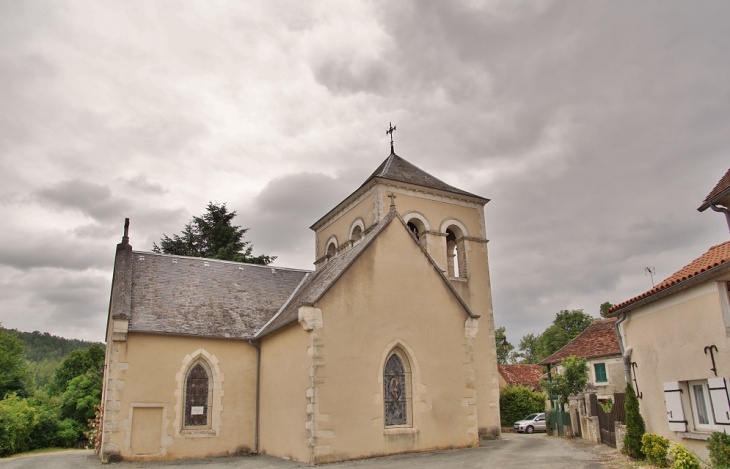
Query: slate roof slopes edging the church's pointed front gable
256 211 479 337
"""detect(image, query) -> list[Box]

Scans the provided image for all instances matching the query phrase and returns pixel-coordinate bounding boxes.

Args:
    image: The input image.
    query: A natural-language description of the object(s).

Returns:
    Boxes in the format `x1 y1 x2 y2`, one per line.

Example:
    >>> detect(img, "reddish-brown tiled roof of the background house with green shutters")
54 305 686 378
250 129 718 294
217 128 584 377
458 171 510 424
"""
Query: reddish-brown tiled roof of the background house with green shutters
540 318 621 365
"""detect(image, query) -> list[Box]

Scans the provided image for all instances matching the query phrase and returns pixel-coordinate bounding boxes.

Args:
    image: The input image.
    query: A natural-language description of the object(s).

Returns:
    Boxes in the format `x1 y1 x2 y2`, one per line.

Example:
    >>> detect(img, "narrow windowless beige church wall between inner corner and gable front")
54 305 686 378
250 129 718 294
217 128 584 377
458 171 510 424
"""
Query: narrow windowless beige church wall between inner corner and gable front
259 323 312 462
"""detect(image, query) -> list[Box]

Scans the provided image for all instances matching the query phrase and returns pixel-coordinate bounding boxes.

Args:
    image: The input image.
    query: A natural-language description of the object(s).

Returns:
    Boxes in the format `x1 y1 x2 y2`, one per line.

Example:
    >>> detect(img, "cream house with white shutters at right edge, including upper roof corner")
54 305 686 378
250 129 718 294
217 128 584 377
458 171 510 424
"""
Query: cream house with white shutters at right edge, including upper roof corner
610 171 730 455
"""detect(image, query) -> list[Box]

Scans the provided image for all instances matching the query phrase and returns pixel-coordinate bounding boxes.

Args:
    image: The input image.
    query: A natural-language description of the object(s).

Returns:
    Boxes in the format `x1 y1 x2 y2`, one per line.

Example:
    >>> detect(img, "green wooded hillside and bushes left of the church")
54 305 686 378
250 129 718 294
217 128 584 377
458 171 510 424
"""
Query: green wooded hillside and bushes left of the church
0 325 104 456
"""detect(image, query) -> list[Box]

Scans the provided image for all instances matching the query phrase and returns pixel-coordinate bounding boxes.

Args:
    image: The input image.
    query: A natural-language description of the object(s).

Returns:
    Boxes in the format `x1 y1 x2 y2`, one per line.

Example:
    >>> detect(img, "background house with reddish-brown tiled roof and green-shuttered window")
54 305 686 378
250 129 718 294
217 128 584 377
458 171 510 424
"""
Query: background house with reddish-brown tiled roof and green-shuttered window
540 318 626 401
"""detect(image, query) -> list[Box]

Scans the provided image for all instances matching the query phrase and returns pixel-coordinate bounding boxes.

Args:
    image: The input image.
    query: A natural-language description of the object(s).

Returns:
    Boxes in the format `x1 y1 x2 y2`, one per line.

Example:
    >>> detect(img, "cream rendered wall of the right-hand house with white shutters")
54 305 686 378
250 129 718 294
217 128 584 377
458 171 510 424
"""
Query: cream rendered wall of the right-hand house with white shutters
621 282 730 455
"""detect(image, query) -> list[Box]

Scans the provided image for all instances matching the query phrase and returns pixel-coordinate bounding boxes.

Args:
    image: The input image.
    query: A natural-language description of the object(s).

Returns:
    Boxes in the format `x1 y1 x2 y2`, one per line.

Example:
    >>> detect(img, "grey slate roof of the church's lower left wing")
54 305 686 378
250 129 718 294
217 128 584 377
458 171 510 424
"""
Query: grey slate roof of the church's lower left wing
129 251 308 339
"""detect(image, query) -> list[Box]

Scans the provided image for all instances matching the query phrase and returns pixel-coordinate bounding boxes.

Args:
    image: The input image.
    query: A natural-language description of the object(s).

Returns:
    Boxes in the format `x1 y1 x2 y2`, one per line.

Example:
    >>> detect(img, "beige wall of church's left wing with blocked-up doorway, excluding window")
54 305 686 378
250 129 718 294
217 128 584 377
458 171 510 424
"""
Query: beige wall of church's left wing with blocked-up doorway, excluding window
103 333 256 460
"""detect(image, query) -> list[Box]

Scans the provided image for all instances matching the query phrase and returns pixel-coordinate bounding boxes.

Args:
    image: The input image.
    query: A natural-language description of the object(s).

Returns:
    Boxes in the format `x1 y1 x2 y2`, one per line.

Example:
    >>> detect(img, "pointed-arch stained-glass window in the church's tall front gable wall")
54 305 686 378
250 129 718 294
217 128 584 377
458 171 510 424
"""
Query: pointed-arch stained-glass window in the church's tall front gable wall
383 349 411 427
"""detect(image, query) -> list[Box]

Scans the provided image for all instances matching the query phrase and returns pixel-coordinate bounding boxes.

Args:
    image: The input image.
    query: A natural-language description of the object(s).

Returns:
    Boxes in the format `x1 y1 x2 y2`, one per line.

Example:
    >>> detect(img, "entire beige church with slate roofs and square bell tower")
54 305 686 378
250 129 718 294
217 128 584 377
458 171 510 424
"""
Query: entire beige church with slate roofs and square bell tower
101 151 500 464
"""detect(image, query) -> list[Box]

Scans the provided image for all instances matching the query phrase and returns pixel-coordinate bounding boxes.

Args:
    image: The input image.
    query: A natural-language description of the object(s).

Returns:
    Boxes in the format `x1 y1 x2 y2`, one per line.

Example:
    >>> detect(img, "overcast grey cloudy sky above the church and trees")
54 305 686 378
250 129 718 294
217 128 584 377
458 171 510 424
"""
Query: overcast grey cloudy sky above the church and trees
0 0 730 344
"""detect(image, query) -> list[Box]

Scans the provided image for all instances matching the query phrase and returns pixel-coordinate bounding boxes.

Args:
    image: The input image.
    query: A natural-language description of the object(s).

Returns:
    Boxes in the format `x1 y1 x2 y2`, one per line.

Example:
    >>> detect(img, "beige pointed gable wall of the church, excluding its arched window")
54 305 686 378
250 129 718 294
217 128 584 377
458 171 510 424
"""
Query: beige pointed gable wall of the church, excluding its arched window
300 220 484 462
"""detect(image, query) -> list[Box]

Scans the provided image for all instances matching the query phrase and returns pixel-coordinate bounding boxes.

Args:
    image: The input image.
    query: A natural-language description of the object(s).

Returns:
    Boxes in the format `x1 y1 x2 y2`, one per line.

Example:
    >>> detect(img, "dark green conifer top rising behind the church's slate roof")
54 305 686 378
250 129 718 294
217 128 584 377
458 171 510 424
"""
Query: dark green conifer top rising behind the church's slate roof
152 202 276 265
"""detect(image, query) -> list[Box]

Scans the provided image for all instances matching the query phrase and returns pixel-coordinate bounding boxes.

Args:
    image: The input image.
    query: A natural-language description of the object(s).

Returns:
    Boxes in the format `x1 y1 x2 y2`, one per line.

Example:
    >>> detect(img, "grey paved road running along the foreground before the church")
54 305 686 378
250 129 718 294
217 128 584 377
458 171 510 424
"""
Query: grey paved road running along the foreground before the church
0 434 621 469
